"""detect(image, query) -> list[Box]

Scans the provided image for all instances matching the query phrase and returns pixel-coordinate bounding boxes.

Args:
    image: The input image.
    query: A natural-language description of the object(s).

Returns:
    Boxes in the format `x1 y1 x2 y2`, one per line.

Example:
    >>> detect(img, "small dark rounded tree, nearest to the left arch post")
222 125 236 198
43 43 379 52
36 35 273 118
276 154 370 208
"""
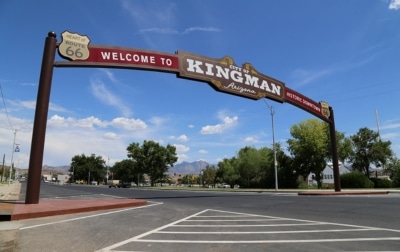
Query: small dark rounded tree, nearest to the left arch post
69 154 106 183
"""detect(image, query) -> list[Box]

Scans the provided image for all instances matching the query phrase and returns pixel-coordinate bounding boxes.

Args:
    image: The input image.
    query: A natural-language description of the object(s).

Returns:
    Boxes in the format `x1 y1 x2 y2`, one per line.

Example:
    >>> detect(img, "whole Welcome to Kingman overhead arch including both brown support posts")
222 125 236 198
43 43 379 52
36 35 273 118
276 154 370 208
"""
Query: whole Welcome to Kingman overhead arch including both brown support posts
25 31 340 204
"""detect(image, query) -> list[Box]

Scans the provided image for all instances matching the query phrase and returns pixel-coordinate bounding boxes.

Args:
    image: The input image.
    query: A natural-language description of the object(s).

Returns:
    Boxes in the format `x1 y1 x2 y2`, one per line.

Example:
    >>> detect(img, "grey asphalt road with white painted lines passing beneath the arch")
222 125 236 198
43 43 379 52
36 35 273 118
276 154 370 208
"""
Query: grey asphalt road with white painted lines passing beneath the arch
10 184 400 252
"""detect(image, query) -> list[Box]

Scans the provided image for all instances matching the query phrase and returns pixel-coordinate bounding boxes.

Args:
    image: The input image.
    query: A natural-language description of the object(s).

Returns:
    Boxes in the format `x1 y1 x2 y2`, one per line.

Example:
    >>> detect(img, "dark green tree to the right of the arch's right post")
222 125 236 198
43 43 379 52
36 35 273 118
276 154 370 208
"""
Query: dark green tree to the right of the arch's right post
350 128 393 178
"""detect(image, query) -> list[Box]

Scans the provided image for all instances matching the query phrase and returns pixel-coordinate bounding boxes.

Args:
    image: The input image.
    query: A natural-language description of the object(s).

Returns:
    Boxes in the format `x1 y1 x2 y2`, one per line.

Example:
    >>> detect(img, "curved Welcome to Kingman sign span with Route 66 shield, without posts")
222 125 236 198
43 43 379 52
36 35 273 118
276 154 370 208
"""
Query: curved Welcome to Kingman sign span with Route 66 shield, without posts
54 31 330 122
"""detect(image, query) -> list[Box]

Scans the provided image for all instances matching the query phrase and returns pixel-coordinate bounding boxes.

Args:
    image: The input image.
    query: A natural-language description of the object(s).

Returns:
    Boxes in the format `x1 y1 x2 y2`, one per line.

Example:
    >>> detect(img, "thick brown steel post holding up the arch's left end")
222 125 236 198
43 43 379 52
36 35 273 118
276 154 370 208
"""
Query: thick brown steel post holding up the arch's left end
25 32 57 204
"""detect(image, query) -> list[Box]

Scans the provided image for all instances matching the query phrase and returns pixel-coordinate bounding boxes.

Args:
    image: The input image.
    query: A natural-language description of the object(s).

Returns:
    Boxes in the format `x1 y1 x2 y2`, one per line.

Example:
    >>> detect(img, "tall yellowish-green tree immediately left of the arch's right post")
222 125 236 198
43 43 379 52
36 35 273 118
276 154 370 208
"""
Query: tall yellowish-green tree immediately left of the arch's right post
287 119 331 188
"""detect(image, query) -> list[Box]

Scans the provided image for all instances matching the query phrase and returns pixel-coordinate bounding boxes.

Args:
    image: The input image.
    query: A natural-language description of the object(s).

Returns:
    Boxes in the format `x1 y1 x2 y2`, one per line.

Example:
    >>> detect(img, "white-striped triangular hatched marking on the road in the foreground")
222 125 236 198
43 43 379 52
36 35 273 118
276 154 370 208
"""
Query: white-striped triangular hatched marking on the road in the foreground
97 209 400 252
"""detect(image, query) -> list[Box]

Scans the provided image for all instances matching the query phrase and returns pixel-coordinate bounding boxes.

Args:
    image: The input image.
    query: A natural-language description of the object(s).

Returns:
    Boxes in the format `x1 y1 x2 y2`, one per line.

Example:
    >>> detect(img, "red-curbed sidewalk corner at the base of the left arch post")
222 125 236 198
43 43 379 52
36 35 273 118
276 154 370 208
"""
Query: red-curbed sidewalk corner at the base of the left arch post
0 182 147 222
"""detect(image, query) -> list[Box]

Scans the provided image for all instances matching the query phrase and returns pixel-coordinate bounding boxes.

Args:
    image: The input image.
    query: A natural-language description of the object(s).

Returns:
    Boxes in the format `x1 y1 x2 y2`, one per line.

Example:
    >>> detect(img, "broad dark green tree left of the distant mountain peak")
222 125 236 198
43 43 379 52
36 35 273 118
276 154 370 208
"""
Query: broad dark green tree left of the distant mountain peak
127 140 178 186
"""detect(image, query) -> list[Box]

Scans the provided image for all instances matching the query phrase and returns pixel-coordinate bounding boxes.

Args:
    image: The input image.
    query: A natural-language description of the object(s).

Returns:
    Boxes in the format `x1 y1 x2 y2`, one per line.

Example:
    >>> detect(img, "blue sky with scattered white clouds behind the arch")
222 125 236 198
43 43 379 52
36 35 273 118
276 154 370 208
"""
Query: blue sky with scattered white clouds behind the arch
0 0 400 168
